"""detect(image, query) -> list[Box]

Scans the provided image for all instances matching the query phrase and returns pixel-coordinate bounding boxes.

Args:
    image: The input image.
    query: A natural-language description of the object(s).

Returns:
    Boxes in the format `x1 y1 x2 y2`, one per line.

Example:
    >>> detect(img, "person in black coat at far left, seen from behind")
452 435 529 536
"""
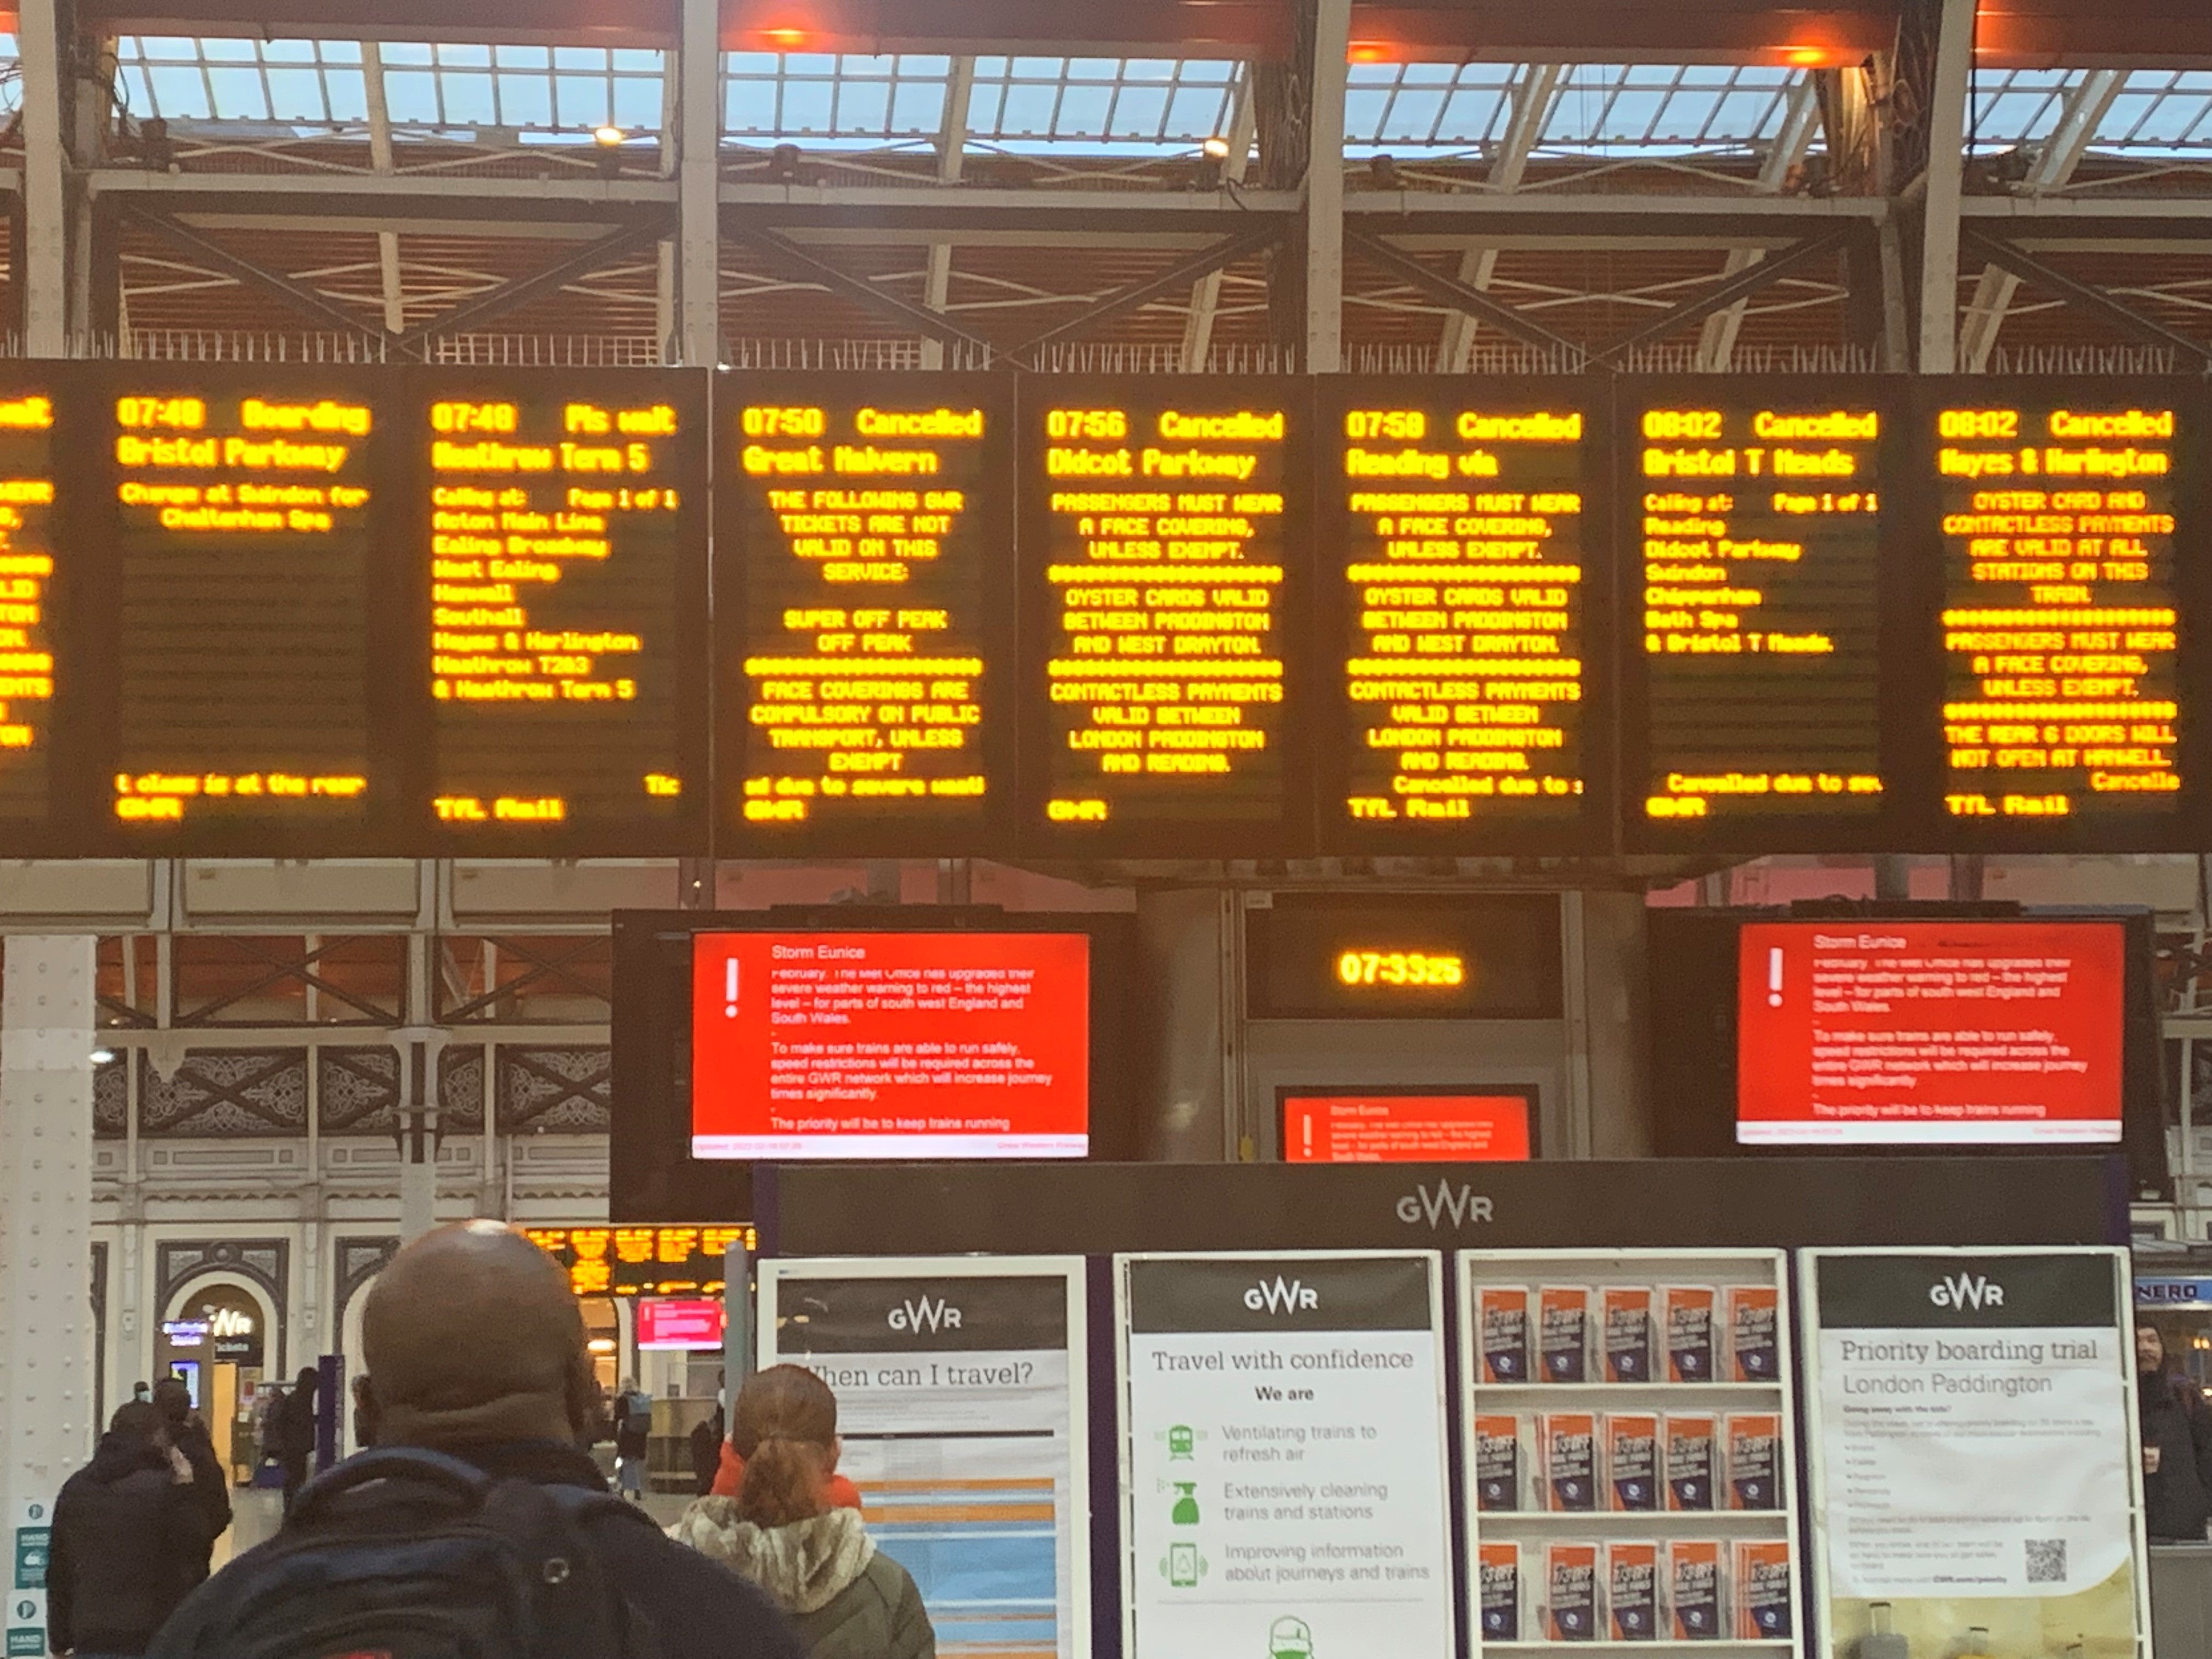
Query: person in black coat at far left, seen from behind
47 1400 208 1659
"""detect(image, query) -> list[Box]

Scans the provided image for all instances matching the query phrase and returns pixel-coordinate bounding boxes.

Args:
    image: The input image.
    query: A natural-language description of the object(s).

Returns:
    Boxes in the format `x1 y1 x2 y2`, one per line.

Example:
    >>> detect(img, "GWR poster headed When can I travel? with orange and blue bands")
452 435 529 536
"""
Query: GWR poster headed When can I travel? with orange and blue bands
761 1256 1091 1659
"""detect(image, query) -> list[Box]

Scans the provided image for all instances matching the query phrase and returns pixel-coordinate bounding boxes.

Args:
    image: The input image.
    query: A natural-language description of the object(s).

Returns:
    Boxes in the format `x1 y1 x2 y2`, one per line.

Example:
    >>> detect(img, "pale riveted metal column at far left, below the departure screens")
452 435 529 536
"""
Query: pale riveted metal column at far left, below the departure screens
0 942 93 1652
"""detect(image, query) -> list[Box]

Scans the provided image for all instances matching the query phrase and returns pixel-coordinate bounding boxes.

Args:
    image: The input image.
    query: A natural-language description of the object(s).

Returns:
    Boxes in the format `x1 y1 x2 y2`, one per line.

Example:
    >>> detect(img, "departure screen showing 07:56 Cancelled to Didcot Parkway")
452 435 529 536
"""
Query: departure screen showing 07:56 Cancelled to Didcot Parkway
1020 376 1312 856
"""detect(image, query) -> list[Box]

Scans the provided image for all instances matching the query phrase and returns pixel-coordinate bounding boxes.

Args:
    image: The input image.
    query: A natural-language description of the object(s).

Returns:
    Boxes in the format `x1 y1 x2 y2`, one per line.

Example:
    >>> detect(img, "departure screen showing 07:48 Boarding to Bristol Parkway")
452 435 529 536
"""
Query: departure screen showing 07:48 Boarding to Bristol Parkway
109 382 378 836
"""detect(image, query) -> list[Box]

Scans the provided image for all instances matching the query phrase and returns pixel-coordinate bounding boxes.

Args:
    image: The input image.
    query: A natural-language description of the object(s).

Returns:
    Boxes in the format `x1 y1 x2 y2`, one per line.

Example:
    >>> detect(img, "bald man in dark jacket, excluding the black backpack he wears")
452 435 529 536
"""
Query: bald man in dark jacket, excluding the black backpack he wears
161 1221 803 1659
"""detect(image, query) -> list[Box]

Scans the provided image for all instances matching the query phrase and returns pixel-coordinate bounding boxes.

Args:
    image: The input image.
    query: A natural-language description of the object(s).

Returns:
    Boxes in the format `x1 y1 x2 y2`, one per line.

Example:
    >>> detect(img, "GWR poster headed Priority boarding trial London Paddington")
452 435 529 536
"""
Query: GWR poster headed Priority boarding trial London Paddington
1805 1248 2148 1659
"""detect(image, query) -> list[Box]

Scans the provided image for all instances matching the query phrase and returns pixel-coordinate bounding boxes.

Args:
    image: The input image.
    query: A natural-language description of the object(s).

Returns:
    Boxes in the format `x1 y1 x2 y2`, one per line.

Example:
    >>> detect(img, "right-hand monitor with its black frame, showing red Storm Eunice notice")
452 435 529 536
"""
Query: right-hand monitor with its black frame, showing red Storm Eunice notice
1648 900 2168 1194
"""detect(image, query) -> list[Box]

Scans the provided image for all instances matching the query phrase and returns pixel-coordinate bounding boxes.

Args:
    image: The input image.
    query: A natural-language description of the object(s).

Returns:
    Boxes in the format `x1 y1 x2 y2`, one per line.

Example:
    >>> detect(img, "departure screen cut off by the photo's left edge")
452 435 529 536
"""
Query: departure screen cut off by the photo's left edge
0 383 55 825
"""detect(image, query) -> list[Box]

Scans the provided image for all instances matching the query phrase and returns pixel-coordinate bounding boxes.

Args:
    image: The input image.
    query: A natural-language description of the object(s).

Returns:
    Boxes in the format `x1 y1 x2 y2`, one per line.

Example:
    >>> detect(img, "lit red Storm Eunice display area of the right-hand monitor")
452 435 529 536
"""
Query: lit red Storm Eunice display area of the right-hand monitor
1736 920 2126 1146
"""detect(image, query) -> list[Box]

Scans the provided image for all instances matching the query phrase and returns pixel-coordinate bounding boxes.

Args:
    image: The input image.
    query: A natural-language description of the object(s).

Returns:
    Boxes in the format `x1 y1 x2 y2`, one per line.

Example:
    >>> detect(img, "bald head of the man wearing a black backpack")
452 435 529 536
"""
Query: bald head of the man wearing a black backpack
360 1221 597 1447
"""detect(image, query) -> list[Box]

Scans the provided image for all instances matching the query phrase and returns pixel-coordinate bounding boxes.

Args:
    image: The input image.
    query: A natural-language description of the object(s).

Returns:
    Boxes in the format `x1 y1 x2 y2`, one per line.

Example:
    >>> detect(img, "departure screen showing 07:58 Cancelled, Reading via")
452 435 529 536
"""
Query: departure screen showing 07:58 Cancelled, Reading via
1316 376 1610 851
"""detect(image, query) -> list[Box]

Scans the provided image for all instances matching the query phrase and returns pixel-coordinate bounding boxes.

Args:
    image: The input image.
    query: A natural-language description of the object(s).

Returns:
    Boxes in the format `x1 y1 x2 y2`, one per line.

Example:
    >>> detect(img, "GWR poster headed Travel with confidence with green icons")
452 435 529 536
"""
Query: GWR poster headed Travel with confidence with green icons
1115 1252 1455 1659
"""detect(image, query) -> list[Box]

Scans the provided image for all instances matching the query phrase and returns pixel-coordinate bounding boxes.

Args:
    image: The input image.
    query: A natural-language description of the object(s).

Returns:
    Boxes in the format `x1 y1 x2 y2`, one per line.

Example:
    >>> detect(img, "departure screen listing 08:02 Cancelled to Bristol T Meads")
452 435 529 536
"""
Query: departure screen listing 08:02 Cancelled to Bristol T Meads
1630 383 1882 838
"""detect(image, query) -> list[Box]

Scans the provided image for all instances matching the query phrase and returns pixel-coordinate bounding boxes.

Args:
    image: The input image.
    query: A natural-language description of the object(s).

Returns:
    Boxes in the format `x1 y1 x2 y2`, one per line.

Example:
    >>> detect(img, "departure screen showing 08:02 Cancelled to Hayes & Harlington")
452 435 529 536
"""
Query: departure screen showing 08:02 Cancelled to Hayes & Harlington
1933 398 2181 832
